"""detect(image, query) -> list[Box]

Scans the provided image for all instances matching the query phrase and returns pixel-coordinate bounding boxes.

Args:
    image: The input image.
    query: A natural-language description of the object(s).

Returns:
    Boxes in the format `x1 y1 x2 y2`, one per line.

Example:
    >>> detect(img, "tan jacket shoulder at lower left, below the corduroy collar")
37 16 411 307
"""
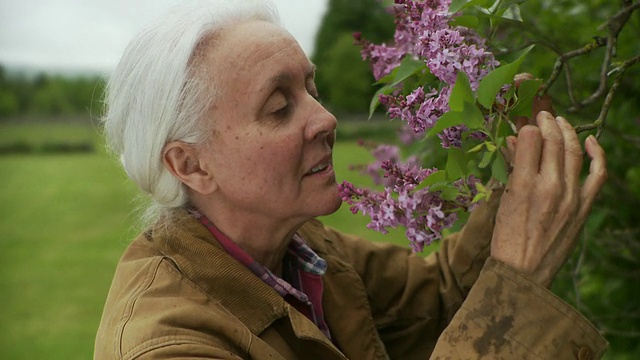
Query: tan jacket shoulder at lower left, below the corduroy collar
95 237 251 359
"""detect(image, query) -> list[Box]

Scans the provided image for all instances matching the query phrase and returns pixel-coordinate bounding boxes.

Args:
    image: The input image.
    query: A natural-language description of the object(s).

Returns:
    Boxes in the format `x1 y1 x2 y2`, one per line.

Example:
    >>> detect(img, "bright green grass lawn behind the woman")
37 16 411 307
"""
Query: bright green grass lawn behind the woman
0 124 424 359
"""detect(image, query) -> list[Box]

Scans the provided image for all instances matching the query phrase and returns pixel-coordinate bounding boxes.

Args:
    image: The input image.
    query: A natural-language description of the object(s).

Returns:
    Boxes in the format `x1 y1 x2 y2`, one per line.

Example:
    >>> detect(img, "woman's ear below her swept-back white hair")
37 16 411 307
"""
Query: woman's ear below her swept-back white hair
162 141 217 195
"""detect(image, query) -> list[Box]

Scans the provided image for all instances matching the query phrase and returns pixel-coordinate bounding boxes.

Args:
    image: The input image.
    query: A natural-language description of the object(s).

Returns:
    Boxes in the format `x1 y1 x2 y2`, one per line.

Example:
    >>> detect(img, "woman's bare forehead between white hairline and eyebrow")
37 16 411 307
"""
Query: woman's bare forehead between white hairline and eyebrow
210 20 313 90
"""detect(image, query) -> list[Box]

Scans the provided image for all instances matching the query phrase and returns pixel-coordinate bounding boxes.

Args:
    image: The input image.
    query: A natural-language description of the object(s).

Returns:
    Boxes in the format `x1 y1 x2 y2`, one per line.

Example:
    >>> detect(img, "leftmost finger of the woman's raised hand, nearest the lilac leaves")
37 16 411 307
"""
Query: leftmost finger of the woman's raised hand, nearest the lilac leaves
509 125 542 188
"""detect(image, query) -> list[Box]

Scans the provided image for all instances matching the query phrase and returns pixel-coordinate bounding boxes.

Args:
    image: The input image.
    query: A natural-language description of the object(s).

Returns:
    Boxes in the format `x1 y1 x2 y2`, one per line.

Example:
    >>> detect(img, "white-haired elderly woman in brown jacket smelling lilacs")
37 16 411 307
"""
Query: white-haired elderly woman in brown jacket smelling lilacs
95 0 606 359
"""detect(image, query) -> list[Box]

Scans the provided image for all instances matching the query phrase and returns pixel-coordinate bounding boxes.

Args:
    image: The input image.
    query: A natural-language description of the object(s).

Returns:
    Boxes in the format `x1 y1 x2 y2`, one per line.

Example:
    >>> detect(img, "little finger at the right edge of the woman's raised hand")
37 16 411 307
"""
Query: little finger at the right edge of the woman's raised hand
580 135 607 218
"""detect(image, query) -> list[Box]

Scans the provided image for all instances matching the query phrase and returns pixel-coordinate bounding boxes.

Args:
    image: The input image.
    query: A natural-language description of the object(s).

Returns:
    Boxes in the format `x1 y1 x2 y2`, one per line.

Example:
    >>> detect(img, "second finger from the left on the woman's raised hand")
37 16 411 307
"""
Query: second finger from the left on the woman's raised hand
536 111 564 177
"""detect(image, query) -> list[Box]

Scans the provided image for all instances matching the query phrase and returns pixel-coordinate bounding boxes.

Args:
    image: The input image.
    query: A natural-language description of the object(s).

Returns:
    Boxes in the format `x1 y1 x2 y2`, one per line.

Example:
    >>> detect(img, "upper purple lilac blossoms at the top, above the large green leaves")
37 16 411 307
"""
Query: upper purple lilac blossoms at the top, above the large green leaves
355 0 498 148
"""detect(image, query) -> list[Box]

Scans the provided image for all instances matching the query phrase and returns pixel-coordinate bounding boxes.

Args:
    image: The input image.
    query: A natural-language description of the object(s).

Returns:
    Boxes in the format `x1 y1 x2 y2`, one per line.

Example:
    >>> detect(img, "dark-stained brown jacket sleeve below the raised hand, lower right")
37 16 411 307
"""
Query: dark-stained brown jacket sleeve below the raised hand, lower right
431 258 607 360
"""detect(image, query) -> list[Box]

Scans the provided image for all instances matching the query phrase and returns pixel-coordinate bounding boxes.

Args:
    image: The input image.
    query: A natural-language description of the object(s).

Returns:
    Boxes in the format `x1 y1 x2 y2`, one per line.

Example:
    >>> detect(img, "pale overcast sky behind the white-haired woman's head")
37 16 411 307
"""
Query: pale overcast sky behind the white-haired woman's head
0 0 326 74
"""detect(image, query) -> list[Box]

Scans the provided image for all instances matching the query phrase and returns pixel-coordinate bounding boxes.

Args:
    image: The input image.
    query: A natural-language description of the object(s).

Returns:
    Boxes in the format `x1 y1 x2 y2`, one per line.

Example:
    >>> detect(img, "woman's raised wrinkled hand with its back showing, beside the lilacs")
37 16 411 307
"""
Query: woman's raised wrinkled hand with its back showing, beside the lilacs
491 111 607 287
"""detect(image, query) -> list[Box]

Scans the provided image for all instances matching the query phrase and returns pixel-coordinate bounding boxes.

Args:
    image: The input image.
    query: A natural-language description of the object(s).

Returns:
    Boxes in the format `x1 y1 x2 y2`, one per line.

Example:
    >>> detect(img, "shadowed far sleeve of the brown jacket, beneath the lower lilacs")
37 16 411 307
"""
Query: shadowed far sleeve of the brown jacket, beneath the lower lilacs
320 188 500 359
